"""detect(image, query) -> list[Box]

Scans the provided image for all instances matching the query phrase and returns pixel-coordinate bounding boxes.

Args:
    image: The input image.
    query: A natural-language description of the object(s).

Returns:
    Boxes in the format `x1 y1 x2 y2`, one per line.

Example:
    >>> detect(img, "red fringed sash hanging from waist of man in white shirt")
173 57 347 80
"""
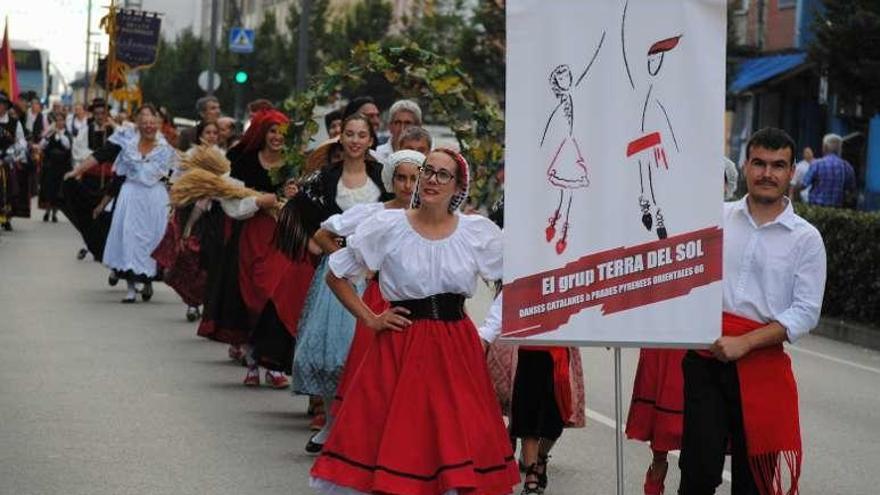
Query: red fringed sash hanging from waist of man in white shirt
722 313 803 495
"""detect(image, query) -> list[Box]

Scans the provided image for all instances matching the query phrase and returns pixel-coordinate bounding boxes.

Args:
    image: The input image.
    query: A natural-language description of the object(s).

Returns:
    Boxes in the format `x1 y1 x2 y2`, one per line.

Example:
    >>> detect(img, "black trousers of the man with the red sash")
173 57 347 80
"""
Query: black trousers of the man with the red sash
678 351 759 495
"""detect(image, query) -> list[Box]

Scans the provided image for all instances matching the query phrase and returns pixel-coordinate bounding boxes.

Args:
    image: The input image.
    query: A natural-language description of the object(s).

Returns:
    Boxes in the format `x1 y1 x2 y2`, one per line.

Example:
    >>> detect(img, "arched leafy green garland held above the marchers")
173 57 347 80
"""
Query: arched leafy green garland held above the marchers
273 43 504 205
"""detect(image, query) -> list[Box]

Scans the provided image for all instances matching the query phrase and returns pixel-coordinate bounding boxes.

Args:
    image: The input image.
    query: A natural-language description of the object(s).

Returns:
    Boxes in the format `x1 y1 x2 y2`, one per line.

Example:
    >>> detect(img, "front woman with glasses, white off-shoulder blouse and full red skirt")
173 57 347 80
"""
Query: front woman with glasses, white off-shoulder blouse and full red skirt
311 150 519 495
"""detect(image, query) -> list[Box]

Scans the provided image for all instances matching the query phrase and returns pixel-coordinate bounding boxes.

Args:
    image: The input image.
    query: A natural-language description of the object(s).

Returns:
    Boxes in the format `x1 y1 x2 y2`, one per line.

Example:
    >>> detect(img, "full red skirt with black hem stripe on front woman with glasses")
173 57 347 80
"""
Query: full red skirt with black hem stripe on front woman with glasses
311 319 519 495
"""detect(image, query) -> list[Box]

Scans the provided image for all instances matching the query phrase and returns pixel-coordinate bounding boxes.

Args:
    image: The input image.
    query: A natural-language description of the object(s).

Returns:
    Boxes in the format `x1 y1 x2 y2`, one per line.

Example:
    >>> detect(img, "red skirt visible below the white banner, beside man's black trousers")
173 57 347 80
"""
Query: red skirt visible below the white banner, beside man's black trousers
626 349 686 452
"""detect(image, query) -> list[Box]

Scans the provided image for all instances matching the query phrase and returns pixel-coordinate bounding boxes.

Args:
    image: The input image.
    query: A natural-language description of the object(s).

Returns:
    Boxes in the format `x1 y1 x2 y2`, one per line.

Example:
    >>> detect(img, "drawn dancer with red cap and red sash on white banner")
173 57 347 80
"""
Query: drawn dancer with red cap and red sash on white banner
621 2 682 239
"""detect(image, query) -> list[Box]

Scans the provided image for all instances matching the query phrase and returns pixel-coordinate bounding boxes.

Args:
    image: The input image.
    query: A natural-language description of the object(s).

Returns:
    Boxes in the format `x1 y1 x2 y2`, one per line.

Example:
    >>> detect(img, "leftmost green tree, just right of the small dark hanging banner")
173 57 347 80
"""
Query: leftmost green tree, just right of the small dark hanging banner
141 29 207 118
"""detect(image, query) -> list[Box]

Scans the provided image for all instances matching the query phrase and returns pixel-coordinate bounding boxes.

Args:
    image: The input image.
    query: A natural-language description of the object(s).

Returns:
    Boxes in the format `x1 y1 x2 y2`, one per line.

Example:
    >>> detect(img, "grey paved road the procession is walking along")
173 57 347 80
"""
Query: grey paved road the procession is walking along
0 221 880 495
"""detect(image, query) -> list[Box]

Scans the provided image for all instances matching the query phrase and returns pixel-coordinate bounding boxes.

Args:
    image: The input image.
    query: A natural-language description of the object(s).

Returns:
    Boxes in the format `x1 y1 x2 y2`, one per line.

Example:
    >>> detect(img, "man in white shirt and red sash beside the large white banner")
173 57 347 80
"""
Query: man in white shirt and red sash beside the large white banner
679 128 826 495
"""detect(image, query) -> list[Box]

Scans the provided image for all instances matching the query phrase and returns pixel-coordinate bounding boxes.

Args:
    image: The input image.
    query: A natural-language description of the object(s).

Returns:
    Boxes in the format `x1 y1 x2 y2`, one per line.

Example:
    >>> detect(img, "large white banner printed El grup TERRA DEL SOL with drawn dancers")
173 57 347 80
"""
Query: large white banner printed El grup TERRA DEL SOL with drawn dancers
502 0 727 347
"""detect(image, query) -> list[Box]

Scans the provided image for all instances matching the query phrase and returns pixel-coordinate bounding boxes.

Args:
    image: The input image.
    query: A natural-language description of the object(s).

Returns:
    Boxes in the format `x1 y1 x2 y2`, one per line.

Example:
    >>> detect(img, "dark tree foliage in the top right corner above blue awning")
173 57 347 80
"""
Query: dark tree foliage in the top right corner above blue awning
810 0 880 114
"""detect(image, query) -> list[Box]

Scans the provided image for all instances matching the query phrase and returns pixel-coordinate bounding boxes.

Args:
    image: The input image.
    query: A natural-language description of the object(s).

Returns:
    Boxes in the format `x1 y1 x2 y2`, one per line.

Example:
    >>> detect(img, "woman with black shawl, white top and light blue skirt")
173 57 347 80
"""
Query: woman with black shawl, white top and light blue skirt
279 114 388 452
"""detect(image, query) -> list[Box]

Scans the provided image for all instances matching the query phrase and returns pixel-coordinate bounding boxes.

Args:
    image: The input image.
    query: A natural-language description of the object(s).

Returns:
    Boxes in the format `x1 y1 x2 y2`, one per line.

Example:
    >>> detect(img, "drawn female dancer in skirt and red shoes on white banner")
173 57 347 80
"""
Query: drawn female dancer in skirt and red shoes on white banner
541 31 605 254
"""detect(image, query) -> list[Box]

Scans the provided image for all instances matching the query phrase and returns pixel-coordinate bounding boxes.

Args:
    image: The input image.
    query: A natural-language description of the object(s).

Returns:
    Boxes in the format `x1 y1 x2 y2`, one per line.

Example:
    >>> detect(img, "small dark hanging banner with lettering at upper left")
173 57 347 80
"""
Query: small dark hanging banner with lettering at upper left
114 10 162 70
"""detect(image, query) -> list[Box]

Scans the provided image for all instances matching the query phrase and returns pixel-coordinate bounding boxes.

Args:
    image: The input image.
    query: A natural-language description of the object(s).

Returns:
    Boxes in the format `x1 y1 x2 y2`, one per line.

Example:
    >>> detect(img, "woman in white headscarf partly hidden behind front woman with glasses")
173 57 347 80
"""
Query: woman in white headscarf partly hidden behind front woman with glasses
306 150 425 453
